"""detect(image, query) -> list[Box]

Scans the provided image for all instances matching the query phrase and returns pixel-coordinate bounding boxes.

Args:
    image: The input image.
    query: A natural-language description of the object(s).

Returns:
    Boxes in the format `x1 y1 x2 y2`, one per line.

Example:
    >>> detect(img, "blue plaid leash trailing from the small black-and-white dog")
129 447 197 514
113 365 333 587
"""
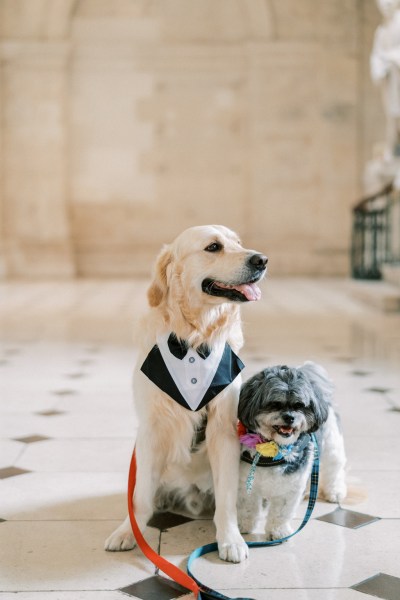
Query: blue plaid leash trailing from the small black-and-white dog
187 433 319 600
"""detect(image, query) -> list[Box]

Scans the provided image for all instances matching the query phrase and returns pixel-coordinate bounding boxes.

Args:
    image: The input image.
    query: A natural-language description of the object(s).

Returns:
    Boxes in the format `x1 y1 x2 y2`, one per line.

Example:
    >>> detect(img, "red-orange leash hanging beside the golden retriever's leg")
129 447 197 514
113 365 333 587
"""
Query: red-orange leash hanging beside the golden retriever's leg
128 450 201 599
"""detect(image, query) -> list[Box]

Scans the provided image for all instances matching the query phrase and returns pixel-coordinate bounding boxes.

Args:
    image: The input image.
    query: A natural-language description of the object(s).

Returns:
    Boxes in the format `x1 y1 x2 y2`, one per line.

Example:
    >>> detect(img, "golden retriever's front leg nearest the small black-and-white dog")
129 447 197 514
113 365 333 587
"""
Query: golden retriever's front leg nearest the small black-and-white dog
207 408 249 563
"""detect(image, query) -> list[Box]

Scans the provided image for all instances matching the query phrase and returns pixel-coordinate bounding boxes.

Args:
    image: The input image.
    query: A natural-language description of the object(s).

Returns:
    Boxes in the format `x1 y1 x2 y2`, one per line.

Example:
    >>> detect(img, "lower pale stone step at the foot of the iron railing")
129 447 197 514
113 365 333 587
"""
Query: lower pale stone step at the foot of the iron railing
350 280 400 312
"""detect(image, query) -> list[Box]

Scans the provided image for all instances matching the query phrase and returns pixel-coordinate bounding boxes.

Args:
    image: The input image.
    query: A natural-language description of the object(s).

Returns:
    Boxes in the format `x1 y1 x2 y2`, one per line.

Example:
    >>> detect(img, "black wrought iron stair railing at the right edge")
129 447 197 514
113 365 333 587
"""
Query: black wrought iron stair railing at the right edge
351 184 400 279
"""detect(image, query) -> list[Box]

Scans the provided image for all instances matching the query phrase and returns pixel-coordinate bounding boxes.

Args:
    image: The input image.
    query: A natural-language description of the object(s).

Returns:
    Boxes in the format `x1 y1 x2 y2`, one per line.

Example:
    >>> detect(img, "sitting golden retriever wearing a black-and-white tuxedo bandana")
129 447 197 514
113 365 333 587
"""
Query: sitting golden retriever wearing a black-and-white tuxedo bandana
105 225 268 562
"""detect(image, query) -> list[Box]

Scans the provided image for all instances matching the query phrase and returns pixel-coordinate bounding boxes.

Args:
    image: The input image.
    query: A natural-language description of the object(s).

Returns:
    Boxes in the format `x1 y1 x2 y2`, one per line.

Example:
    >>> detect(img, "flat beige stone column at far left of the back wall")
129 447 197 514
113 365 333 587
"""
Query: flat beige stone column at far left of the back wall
0 40 75 277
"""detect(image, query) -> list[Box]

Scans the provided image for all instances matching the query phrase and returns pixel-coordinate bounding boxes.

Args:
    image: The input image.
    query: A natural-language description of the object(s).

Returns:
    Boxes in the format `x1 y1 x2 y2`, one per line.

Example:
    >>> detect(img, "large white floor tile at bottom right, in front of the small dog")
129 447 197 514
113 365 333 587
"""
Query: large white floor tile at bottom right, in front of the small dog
161 520 400 590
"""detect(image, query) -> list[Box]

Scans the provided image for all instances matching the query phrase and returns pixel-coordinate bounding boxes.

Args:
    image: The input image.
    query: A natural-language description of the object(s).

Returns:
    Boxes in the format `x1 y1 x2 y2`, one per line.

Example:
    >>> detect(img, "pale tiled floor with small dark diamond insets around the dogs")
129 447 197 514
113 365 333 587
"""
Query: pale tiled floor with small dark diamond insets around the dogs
0 279 400 600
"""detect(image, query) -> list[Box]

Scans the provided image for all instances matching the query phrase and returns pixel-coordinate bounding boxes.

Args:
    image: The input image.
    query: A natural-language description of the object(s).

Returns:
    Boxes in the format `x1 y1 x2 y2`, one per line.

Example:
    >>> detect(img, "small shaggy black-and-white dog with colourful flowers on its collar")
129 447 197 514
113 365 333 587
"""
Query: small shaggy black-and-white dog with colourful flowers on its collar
238 362 347 540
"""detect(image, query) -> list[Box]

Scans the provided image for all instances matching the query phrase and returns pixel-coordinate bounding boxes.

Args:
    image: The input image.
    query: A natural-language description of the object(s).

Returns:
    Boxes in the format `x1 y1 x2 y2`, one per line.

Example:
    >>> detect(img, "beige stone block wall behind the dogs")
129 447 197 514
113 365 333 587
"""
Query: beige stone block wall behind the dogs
0 0 383 277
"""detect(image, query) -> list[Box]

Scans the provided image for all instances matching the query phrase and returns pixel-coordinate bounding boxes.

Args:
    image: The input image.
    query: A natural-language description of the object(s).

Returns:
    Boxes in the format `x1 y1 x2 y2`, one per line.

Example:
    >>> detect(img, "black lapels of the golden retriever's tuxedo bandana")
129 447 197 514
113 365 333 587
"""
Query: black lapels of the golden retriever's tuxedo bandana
141 344 244 411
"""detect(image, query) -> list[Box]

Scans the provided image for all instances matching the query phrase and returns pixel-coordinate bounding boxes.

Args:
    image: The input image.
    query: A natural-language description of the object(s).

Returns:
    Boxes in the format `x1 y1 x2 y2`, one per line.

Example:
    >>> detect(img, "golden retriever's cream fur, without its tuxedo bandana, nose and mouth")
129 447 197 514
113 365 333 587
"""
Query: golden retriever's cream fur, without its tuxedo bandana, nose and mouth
106 225 267 562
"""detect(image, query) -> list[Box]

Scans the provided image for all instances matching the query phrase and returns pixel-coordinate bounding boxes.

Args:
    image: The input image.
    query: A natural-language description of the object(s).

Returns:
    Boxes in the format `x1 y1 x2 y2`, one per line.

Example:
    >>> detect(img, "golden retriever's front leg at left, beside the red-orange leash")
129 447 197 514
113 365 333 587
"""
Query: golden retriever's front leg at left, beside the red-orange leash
104 436 162 552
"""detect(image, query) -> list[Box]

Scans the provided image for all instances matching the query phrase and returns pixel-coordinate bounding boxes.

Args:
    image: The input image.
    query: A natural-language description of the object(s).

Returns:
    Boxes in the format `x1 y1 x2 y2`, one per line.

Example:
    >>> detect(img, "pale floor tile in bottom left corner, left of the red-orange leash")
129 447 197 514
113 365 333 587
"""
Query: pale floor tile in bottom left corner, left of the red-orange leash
0 521 159 592
